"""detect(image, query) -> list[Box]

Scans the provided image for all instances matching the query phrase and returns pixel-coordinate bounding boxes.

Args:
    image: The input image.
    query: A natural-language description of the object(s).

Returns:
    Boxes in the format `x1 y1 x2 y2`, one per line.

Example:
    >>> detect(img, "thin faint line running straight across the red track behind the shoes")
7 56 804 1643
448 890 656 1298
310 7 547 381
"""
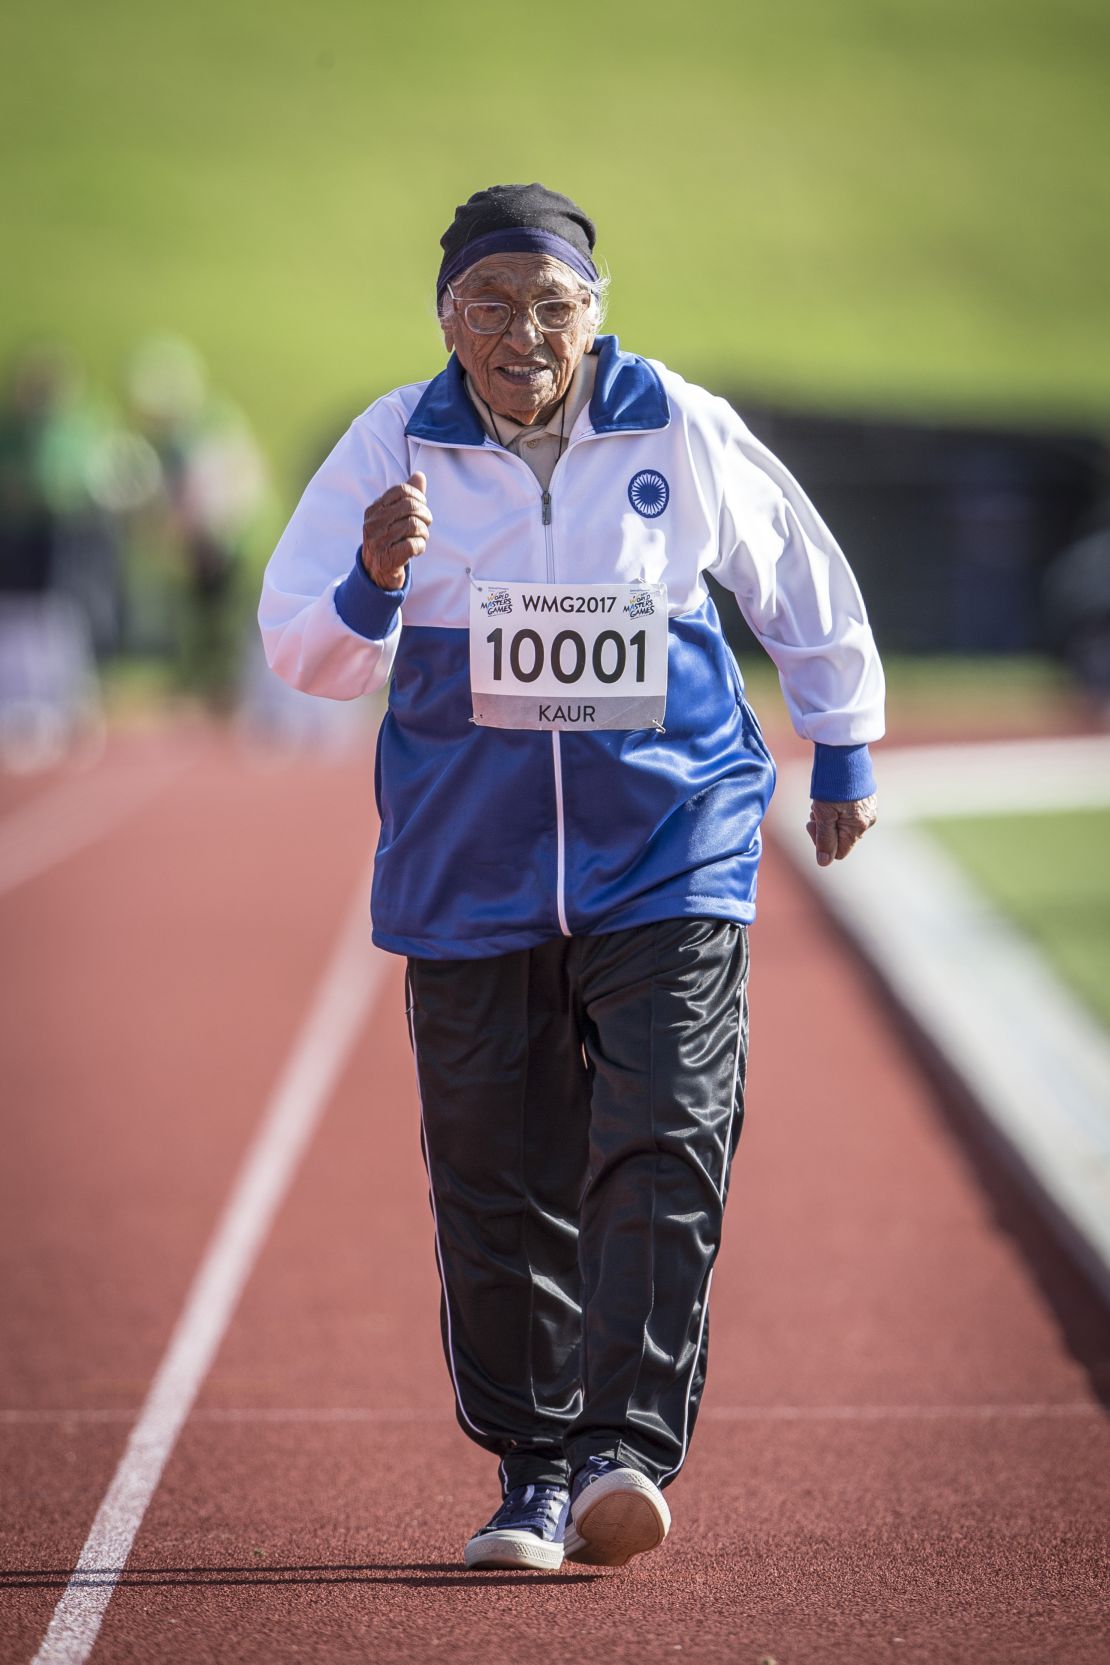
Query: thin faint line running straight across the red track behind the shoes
0 1400 1107 1427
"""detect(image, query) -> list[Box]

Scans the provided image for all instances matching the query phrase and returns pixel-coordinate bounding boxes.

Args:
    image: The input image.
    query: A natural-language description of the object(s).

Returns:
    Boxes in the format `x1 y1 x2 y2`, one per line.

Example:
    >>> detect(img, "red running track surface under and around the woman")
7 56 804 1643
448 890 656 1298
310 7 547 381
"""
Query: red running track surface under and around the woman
0 729 1110 1665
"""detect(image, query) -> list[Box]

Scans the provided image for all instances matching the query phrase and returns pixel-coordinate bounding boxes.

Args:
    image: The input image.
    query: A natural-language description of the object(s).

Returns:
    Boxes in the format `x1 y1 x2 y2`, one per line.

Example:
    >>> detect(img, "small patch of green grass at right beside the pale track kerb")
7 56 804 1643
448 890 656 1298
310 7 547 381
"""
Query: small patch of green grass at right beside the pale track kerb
927 809 1110 1027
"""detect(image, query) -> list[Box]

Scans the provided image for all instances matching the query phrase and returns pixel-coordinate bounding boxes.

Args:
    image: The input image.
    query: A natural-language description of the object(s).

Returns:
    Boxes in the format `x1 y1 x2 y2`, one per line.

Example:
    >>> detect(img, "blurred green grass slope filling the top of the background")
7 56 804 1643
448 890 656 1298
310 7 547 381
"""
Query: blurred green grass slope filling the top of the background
0 0 1110 488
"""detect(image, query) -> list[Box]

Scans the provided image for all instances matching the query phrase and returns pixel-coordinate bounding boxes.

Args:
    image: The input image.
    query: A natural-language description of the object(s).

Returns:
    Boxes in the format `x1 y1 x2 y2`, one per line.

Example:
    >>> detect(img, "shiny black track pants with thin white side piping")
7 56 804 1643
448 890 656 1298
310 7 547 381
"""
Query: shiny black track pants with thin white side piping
408 919 747 1485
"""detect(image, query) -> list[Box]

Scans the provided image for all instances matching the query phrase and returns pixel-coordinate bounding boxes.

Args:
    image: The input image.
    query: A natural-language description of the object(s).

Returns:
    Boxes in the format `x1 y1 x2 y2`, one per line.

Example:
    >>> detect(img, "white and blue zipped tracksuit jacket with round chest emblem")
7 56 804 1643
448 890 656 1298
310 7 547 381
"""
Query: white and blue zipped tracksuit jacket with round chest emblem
260 336 884 959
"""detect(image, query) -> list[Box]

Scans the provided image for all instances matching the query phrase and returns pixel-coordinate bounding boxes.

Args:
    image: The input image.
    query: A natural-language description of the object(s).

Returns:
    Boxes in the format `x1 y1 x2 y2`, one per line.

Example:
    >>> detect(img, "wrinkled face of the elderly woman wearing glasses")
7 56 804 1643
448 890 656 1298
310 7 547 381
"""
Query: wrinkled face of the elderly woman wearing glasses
443 255 596 428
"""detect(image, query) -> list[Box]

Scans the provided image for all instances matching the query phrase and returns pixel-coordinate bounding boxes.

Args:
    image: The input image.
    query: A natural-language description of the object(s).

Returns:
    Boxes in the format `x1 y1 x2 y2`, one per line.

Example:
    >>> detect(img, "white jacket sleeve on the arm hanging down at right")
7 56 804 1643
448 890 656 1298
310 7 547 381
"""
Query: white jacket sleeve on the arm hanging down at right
711 410 885 746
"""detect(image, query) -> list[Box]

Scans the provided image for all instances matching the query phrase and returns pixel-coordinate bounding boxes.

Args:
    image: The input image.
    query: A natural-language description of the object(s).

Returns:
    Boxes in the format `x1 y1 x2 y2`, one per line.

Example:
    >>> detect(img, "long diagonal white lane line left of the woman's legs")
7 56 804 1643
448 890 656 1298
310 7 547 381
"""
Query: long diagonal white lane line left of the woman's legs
33 881 386 1665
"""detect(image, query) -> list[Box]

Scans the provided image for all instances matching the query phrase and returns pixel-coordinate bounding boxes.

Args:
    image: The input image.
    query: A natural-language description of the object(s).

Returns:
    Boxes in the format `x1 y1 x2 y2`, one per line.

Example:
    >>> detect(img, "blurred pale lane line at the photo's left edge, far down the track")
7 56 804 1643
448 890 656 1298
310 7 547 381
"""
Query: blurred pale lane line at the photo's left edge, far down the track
0 761 188 896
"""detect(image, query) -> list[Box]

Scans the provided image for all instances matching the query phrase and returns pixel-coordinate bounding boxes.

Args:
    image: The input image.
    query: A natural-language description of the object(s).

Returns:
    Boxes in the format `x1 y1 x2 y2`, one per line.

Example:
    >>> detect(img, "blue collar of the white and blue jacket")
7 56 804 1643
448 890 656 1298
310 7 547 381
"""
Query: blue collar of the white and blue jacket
404 335 671 445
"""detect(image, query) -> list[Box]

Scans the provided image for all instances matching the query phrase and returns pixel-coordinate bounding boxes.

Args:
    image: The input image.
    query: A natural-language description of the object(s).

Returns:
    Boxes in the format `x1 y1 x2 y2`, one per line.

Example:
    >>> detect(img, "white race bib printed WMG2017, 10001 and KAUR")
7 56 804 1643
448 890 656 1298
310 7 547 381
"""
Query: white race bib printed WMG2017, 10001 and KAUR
471 579 667 731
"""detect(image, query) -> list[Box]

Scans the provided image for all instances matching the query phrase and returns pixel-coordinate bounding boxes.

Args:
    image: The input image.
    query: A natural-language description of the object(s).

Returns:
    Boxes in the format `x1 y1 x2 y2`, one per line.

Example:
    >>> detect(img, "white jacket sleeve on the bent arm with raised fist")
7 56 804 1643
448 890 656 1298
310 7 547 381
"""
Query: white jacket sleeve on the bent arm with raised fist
258 419 409 699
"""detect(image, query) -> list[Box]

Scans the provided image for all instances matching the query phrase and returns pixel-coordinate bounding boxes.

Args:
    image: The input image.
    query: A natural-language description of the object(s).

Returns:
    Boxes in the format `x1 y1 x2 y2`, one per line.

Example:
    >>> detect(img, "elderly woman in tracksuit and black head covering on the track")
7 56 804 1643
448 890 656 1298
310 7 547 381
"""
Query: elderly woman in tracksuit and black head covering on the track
260 185 884 1568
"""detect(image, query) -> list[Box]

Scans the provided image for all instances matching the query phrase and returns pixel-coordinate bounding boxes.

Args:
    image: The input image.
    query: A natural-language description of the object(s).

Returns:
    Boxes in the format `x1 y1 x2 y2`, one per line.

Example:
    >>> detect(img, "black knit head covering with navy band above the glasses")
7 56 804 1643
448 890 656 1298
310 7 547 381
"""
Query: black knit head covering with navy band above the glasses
436 185 597 295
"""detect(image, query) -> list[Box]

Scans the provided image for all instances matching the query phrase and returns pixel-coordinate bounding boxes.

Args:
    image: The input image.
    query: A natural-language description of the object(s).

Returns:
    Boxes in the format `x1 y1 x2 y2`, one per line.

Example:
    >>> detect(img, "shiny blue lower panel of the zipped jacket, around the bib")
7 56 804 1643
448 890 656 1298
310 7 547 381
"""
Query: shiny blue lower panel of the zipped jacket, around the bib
373 599 774 959
